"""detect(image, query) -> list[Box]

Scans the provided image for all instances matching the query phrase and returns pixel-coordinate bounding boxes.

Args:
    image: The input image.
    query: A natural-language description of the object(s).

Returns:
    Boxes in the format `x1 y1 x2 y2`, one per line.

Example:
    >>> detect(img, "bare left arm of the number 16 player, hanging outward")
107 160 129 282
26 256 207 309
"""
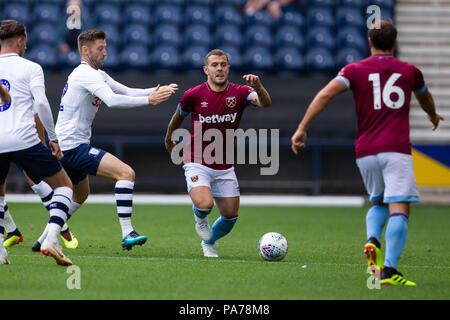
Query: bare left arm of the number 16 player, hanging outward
291 79 347 154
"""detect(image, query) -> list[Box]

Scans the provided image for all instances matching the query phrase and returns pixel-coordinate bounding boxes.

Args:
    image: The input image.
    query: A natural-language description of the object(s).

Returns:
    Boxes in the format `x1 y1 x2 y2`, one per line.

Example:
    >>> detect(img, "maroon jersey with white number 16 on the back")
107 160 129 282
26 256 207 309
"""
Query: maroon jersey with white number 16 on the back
336 55 426 158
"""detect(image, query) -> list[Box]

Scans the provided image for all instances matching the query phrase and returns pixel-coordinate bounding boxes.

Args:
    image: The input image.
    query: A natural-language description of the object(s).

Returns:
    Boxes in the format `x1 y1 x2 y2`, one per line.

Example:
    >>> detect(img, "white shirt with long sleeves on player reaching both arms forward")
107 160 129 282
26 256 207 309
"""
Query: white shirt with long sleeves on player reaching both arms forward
55 62 152 151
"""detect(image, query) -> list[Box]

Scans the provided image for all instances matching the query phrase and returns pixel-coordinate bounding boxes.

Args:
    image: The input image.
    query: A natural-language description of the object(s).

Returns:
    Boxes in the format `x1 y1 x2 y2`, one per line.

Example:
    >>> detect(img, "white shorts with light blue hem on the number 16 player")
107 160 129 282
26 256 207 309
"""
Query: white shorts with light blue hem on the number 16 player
356 152 419 203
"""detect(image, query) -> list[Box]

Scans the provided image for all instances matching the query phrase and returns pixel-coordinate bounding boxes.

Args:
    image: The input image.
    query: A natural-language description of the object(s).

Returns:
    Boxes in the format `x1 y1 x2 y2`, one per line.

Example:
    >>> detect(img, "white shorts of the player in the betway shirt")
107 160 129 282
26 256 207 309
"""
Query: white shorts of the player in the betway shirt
183 162 240 198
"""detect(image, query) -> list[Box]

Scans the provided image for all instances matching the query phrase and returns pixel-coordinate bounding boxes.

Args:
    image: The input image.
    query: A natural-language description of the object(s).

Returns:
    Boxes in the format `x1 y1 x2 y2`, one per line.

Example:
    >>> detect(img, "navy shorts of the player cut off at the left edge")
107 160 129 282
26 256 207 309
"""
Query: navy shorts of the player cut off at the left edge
0 142 62 184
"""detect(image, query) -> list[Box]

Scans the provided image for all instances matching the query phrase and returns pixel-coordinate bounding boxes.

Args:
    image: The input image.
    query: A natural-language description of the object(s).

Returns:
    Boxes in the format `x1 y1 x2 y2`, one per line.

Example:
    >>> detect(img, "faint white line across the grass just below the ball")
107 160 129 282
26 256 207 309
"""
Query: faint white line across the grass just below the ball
9 254 450 269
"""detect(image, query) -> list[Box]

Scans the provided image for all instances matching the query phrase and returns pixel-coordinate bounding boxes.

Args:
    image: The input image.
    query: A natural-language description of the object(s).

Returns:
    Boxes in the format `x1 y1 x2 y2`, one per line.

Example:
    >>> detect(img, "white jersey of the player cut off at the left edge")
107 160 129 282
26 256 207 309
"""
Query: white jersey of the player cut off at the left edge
0 53 45 153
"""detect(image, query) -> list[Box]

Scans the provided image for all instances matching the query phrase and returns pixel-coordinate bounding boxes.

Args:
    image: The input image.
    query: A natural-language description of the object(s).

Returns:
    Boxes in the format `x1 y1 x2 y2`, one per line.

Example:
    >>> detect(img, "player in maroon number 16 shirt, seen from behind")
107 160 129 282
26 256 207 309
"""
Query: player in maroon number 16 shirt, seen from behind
291 20 443 286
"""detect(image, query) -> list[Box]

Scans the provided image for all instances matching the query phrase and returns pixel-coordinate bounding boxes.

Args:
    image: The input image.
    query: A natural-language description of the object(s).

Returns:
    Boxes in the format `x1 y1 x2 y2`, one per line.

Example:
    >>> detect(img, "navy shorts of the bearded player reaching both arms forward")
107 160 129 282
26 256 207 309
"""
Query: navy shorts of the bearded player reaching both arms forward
61 143 106 185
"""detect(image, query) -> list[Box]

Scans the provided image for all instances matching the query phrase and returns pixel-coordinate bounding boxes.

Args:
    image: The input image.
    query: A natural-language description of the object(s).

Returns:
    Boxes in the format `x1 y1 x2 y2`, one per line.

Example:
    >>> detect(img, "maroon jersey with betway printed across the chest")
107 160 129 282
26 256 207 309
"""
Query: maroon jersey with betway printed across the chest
178 82 254 170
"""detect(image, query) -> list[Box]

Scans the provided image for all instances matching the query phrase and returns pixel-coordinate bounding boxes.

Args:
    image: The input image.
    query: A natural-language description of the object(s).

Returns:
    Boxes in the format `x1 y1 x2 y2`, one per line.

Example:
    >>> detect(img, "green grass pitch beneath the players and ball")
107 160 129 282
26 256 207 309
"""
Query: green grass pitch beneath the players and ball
0 203 450 300
